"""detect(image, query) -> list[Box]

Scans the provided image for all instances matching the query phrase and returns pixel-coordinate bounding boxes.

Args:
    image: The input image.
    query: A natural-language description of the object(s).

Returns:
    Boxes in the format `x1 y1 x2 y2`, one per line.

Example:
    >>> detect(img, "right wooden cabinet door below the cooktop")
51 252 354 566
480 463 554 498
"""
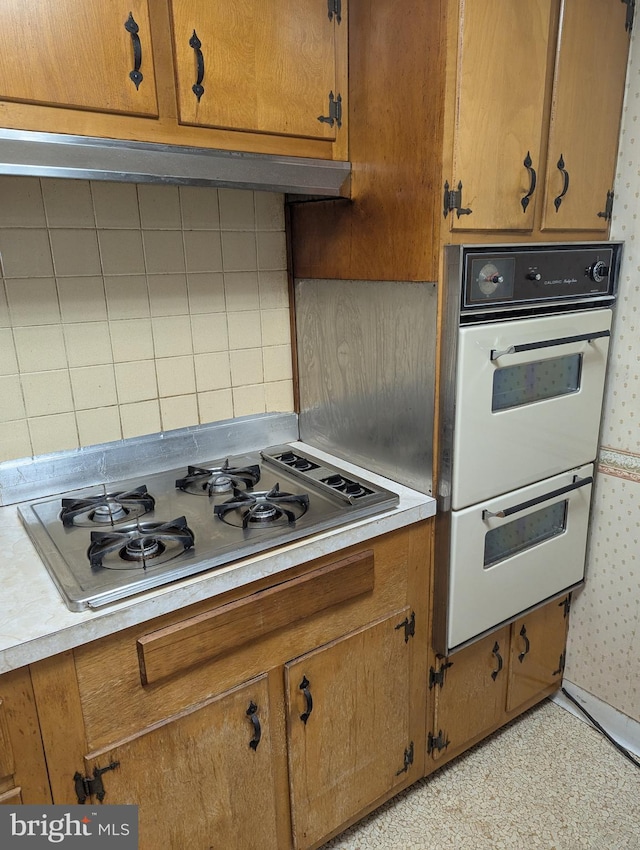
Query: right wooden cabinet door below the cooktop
285 608 417 850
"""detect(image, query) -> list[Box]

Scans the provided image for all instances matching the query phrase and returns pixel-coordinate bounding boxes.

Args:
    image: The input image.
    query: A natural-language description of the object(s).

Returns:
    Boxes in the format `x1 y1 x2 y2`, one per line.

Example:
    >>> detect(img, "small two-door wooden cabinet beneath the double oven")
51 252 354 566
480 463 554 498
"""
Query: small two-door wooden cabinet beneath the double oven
427 597 569 772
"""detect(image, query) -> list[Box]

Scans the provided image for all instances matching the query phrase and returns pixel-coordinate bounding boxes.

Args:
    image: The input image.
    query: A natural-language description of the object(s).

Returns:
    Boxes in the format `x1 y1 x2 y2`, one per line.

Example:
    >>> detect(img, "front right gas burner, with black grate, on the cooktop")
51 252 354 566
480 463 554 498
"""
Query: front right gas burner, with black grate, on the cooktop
213 484 309 529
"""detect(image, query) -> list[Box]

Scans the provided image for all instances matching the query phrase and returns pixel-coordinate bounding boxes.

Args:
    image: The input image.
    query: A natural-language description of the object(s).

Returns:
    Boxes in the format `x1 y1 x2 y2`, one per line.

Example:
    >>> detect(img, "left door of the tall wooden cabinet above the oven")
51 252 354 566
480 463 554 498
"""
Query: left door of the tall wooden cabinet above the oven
448 0 552 230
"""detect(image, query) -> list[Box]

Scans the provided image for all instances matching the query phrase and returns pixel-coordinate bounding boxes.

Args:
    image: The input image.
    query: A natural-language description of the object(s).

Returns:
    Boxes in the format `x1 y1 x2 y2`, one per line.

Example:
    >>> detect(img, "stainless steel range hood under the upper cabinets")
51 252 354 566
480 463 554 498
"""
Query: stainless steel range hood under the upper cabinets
0 129 351 198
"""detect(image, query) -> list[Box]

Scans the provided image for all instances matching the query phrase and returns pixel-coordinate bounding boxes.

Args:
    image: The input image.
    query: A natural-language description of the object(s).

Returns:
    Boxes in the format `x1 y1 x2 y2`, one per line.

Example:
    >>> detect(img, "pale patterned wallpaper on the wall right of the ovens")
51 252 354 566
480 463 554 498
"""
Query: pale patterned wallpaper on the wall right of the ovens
565 35 640 721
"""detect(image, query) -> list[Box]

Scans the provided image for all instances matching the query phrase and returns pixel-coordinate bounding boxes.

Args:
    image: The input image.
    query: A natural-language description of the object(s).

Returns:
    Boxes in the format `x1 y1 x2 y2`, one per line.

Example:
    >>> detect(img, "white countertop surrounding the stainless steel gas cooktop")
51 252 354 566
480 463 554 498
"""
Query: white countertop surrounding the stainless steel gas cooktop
0 443 436 673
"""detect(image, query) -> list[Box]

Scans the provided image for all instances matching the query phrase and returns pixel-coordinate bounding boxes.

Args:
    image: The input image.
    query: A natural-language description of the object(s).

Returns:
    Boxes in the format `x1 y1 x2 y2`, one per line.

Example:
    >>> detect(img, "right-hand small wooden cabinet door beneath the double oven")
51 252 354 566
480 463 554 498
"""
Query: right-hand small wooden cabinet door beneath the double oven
507 597 568 711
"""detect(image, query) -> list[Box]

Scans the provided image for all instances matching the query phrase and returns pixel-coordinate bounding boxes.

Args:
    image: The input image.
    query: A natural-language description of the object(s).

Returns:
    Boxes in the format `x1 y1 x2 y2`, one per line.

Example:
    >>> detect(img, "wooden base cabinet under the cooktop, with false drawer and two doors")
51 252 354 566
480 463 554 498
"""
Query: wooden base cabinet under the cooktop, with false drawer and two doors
21 521 433 850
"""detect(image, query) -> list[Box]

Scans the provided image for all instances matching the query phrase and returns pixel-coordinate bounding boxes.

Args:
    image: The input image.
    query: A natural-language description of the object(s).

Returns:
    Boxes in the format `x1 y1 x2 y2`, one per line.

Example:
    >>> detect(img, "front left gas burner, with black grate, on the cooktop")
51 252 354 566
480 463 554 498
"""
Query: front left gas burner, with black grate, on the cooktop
87 516 195 570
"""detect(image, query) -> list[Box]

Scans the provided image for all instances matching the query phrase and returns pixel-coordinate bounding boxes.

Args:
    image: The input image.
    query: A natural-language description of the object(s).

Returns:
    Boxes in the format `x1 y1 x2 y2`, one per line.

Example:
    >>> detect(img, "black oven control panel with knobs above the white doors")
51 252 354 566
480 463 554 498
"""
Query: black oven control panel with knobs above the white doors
452 242 622 315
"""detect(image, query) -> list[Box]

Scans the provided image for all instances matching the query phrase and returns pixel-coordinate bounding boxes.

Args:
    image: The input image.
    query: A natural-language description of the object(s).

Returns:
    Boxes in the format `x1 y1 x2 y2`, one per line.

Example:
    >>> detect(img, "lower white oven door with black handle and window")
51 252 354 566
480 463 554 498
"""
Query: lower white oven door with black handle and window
448 464 593 650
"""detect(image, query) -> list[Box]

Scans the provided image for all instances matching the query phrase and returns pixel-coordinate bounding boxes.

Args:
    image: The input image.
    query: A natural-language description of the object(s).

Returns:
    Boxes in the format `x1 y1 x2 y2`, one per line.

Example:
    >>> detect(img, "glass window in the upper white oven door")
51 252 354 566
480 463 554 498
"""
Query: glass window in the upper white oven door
491 354 582 413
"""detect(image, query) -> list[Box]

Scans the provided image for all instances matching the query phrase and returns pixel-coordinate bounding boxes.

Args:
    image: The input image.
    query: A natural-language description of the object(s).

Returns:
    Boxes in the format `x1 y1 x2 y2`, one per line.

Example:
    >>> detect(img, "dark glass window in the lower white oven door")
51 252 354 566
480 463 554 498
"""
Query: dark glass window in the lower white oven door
484 500 567 569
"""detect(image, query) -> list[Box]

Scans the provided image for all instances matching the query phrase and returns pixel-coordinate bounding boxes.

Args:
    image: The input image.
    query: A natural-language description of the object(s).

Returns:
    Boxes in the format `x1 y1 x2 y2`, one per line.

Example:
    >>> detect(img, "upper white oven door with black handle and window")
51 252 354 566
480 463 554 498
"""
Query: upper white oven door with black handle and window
451 309 612 510
